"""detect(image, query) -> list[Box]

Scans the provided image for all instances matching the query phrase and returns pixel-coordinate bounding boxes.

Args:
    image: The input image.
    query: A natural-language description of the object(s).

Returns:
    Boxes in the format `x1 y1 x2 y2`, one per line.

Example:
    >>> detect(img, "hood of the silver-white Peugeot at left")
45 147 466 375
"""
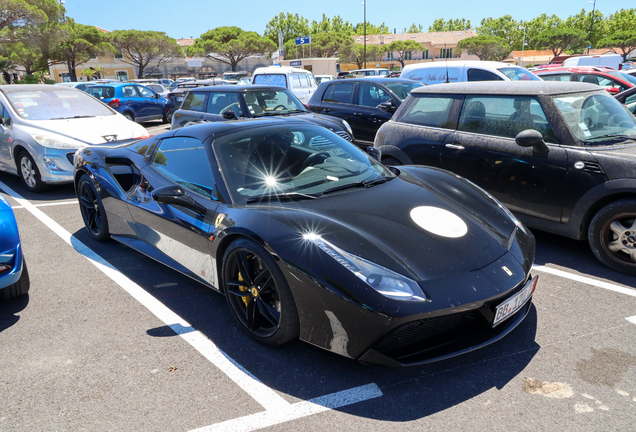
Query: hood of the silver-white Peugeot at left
25 114 149 145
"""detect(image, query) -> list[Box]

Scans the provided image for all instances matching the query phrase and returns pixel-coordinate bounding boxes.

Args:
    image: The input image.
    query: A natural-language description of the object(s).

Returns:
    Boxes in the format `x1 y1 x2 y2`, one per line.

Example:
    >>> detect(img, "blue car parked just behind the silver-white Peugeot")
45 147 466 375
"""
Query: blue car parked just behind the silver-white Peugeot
86 83 168 123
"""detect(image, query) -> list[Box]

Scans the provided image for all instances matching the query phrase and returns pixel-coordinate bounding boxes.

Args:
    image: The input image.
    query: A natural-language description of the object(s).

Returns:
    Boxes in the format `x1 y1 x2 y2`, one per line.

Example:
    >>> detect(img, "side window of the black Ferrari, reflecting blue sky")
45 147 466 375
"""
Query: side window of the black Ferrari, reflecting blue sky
152 137 218 200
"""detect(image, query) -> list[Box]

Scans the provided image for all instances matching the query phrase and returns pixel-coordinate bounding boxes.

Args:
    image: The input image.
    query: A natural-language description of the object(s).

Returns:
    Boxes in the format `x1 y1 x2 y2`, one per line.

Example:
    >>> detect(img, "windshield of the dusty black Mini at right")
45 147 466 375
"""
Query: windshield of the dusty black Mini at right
553 92 636 146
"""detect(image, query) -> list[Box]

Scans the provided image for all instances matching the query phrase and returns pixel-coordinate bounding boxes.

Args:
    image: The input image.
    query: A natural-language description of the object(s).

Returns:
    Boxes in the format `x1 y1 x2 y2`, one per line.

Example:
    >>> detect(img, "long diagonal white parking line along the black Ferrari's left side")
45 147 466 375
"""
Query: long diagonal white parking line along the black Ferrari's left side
0 182 290 409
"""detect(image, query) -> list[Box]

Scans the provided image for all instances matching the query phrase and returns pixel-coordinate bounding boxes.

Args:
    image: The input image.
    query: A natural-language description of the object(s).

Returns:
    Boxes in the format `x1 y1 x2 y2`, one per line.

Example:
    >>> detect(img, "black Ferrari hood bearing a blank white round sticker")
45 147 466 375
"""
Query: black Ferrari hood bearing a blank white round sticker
264 167 515 280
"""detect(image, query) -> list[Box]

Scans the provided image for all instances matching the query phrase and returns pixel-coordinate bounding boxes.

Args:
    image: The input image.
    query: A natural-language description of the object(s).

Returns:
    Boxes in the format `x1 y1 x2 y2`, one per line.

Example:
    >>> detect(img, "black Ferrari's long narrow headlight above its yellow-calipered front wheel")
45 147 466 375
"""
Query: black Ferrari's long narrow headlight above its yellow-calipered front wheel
303 234 426 301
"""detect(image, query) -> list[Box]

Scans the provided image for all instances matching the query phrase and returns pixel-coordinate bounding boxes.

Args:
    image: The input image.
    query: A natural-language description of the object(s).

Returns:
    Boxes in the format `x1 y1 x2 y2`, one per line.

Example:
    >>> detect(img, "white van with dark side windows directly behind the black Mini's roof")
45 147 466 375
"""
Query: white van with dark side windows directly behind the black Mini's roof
400 60 541 85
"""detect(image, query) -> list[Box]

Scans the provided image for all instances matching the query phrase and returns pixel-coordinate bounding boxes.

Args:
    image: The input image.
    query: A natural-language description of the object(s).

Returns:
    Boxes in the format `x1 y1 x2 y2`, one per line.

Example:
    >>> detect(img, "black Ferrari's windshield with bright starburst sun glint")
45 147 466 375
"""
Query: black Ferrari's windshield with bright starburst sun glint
212 124 394 205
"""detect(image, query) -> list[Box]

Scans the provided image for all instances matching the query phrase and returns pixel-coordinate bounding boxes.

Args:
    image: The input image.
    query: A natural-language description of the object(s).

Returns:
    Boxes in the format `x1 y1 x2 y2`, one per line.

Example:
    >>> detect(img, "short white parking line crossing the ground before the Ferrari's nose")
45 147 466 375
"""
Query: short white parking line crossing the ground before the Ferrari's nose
190 384 382 432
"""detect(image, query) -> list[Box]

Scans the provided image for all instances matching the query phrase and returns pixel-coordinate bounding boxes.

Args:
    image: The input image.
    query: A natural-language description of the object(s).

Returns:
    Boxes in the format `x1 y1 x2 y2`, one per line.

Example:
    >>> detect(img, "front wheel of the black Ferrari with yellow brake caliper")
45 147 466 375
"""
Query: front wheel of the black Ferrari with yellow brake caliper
222 238 299 346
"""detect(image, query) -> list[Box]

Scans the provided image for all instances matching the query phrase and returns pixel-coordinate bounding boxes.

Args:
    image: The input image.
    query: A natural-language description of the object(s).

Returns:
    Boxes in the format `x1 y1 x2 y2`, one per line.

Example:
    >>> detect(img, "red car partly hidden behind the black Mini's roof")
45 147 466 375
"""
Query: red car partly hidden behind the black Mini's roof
534 66 636 95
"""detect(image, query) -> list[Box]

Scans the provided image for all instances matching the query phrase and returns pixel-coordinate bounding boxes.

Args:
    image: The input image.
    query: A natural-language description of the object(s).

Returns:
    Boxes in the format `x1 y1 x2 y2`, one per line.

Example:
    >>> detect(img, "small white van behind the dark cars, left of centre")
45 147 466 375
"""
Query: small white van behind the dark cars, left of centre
252 66 318 105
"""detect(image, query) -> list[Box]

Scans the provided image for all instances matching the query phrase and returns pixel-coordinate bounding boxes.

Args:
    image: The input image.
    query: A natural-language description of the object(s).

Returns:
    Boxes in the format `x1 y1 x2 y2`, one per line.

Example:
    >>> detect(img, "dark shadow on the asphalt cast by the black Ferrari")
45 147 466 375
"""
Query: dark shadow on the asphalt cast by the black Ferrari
74 229 540 421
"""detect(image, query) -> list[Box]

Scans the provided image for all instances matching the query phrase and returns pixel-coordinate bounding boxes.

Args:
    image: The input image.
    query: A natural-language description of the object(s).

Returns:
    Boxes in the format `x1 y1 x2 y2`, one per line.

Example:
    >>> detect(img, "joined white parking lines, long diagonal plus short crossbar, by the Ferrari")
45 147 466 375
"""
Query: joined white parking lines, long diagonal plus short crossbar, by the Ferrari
0 181 382 430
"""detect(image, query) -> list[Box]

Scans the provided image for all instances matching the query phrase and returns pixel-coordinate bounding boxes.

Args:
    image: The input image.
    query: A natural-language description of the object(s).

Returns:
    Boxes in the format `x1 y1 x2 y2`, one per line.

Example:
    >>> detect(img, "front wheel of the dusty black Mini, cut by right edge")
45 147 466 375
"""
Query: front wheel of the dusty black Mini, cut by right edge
588 199 636 275
